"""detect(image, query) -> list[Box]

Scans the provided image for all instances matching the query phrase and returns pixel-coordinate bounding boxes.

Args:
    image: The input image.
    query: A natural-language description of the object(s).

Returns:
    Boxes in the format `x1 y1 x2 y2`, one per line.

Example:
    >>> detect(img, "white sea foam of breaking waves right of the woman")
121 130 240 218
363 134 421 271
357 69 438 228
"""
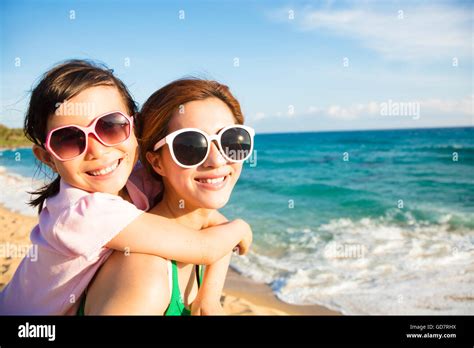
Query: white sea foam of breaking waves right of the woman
233 214 474 315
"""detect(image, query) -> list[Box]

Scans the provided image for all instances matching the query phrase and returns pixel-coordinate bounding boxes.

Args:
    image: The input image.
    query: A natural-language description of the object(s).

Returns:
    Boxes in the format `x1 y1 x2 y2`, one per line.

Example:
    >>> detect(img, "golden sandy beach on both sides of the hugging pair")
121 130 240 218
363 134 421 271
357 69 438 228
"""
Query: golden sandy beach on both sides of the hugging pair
0 205 340 315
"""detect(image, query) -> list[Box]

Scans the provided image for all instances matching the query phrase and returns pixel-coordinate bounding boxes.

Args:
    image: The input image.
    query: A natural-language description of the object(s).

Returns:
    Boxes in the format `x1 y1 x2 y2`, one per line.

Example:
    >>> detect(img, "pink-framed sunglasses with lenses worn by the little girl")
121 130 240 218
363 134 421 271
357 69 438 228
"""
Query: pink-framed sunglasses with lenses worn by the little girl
45 111 133 161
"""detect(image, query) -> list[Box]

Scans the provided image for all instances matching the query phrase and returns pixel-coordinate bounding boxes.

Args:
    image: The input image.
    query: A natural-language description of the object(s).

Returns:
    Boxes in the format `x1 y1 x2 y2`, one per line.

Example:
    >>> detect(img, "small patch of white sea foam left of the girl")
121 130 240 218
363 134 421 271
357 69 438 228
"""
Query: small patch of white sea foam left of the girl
0 166 42 216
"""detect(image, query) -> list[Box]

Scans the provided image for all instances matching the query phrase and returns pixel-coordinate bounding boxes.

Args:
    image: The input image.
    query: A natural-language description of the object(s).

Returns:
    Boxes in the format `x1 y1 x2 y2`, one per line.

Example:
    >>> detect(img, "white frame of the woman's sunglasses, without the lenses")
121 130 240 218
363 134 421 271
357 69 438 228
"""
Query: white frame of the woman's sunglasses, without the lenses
153 124 255 169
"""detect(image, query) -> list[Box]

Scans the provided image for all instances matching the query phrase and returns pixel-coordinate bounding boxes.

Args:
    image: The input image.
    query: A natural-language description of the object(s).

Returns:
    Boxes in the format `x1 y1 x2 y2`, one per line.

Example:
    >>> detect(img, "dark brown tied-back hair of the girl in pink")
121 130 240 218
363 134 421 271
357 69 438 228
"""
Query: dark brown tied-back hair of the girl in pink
23 60 137 213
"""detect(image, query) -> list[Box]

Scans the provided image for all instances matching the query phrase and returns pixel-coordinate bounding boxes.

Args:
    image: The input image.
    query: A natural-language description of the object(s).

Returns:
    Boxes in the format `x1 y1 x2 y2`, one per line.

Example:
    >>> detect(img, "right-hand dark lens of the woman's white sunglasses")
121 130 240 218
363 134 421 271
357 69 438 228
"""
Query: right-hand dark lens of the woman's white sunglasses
221 127 252 161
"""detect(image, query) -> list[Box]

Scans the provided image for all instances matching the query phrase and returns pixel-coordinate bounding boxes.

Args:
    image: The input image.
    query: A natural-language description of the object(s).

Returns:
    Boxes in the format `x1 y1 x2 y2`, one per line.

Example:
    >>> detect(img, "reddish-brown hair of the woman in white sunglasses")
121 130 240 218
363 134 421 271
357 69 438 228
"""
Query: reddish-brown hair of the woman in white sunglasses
137 78 244 202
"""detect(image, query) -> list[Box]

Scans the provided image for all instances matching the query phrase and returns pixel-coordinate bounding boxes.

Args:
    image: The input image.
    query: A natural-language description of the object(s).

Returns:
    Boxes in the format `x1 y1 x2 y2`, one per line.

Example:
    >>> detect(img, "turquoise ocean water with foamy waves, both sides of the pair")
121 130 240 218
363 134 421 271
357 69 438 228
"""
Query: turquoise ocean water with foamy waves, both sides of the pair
0 128 474 314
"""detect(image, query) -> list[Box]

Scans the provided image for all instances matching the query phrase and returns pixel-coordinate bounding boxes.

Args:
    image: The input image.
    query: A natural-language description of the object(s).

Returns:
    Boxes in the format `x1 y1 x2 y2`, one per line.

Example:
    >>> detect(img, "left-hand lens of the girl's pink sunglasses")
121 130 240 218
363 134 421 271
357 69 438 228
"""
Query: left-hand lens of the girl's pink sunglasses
49 127 86 160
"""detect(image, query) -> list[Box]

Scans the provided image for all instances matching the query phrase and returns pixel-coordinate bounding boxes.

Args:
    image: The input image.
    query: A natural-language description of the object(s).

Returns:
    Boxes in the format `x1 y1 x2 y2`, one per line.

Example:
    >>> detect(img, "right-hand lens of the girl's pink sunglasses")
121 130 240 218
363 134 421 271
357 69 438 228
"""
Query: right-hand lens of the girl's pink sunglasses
95 113 130 145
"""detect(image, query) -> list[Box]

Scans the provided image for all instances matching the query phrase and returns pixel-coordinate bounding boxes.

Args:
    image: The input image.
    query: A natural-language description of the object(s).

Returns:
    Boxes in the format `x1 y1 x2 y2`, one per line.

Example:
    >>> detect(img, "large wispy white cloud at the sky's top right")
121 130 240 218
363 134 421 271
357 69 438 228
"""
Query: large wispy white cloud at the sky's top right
271 3 473 61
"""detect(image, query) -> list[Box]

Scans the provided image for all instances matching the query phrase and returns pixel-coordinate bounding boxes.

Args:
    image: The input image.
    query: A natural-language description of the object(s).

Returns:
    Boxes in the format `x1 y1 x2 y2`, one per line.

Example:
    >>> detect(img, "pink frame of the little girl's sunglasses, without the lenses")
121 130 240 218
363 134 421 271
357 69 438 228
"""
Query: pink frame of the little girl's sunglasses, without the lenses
45 111 133 162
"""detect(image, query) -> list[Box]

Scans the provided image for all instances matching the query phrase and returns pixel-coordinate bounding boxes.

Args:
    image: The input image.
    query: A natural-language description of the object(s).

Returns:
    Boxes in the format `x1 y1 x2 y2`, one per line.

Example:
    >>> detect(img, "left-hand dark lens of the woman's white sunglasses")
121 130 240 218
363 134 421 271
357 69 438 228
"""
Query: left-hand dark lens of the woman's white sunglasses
173 131 207 166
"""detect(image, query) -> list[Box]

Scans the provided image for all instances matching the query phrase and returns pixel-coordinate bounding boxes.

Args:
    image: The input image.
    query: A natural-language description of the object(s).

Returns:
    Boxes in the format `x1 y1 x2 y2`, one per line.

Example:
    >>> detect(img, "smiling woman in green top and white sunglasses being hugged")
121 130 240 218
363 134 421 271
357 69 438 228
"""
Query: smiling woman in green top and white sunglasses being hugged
86 79 254 315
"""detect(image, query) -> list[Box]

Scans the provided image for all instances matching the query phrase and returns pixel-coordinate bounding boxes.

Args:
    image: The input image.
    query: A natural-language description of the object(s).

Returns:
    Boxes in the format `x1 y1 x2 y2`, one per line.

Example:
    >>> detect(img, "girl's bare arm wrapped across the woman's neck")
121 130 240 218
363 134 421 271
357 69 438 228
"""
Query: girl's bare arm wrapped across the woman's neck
106 213 252 265
